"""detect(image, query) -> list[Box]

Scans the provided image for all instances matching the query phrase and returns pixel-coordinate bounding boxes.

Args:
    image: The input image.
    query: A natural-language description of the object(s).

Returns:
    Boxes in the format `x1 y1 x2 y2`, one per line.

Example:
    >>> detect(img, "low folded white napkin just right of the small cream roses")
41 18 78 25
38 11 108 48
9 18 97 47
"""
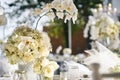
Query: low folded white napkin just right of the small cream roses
65 61 91 80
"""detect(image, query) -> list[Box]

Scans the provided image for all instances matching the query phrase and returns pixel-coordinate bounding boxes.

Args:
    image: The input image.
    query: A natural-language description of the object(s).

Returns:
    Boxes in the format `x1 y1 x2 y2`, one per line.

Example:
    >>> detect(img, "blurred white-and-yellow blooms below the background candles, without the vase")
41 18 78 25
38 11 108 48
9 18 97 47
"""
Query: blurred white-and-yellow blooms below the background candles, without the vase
84 13 120 40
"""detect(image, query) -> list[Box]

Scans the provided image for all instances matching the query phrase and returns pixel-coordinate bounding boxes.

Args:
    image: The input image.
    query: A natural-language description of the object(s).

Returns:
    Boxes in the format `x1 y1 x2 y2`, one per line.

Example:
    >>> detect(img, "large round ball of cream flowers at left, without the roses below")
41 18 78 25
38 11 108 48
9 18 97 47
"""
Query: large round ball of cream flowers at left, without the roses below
4 26 52 64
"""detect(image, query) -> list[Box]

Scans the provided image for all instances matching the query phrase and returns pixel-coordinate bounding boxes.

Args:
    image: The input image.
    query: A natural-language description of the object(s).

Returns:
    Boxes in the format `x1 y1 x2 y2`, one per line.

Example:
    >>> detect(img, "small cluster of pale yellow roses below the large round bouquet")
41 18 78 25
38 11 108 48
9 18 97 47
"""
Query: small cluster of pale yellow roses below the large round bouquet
34 57 59 78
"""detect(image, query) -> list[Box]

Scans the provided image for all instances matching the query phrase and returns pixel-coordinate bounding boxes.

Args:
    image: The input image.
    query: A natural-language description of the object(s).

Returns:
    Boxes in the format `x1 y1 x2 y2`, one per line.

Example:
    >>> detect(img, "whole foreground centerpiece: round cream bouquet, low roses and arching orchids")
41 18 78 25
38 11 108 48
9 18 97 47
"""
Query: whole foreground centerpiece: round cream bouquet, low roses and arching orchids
4 0 78 80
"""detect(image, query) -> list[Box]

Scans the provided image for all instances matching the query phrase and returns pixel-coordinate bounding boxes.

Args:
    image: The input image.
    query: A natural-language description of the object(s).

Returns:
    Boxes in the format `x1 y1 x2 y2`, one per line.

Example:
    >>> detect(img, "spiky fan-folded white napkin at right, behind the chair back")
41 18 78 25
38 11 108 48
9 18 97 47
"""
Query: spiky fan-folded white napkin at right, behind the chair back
84 41 120 73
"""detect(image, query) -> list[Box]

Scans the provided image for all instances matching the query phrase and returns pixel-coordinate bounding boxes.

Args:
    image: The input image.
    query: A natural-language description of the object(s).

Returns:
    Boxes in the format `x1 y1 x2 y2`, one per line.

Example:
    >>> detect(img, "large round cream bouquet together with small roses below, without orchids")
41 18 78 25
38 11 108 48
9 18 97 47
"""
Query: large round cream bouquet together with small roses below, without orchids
4 26 58 78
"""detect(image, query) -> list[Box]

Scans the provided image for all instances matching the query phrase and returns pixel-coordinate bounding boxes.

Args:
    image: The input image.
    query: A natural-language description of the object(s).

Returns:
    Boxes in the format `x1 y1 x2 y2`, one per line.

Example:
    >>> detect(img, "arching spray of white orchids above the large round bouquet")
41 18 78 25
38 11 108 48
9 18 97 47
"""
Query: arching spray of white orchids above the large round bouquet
34 0 78 28
